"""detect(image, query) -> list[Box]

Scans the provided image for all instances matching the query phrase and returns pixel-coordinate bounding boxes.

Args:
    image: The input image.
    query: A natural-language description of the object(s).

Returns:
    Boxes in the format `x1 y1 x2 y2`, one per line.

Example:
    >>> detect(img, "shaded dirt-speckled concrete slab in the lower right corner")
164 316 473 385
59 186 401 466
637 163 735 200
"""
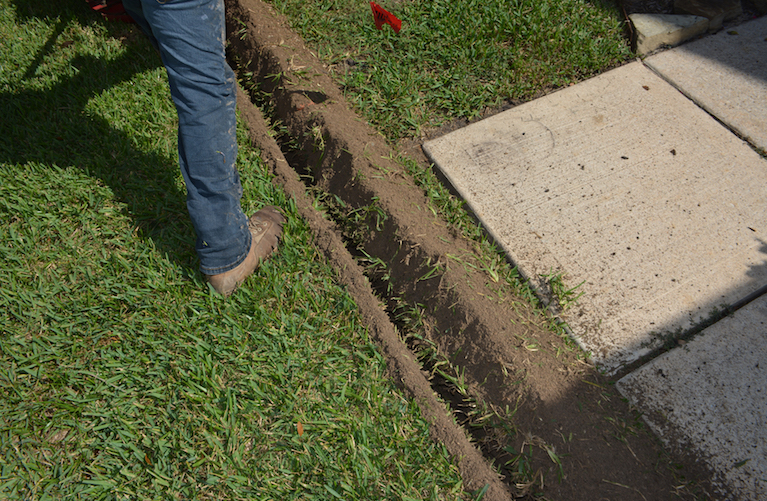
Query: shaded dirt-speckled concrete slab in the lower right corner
617 296 767 501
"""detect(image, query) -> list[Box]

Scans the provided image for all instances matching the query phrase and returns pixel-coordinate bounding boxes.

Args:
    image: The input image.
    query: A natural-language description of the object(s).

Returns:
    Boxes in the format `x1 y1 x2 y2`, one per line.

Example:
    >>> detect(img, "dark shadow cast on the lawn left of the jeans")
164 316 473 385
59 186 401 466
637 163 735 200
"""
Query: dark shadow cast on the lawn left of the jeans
0 0 197 268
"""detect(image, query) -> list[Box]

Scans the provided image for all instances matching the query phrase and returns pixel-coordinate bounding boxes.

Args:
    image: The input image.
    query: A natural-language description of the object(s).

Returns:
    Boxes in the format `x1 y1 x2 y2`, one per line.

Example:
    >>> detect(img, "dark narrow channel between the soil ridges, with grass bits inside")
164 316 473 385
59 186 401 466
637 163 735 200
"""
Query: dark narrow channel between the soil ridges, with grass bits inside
243 88 534 497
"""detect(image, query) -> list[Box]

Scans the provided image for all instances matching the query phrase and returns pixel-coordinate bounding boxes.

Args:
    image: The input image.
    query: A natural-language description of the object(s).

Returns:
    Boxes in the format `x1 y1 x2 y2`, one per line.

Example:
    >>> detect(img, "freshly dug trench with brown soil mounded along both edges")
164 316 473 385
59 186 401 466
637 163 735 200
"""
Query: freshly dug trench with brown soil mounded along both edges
226 0 710 501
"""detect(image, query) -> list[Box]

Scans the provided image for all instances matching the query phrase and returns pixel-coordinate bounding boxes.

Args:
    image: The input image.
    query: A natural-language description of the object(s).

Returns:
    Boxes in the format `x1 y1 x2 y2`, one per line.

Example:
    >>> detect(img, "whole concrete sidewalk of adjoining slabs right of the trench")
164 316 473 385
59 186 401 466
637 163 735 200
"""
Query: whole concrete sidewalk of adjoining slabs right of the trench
424 13 767 499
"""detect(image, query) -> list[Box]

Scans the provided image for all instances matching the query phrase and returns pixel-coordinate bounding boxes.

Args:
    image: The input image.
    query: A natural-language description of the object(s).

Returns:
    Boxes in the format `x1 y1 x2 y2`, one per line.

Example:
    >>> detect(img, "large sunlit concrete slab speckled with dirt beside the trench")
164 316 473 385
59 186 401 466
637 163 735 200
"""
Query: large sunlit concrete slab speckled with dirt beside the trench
424 62 767 373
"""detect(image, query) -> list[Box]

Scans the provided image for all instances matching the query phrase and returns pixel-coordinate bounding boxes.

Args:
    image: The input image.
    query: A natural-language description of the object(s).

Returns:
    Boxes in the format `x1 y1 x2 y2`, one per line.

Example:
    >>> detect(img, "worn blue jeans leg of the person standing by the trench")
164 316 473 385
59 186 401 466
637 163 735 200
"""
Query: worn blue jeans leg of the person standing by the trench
123 0 251 275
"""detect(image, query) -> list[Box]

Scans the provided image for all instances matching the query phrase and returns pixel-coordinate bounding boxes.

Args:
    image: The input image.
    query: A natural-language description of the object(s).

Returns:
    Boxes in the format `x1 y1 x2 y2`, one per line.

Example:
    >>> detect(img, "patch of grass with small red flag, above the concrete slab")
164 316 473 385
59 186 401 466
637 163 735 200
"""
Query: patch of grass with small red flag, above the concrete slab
270 0 631 141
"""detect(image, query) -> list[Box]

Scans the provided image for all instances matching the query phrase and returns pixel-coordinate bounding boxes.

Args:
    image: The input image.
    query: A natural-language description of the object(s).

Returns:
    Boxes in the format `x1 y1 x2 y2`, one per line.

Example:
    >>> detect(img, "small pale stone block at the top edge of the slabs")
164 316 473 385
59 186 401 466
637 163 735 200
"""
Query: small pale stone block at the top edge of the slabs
629 14 708 55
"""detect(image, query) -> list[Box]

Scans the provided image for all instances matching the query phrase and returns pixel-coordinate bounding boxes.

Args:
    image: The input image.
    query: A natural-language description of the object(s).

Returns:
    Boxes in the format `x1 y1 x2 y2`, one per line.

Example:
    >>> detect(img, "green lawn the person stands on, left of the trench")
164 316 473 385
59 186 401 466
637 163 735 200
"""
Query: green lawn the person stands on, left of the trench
0 0 466 500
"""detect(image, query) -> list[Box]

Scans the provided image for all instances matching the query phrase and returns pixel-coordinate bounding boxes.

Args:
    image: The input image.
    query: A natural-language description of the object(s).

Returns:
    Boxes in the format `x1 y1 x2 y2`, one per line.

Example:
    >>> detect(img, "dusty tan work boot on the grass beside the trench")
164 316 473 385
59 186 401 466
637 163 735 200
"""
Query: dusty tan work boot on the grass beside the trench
206 206 285 297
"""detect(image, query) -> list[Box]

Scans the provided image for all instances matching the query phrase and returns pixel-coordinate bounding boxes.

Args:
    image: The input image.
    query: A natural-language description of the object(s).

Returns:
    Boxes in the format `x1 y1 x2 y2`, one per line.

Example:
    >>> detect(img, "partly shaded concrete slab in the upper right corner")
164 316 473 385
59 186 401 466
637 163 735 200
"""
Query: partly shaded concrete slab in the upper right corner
645 17 767 149
